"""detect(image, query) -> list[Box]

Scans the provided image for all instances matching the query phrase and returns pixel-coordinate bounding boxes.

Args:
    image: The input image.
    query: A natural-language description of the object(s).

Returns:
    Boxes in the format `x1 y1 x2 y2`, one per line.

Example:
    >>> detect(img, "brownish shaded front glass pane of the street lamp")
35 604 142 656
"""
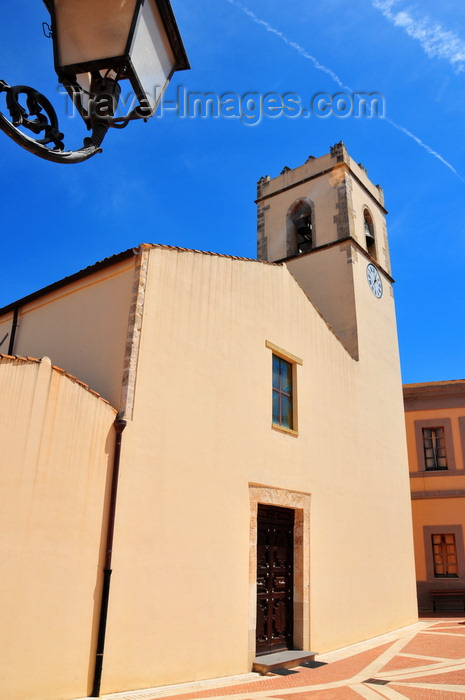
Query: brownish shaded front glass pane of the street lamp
54 0 137 68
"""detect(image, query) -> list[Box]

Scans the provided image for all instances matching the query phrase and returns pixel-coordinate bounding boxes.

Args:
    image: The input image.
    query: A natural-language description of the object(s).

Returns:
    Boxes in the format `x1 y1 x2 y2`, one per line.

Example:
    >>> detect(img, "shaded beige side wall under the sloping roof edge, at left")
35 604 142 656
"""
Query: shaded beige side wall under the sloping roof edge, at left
0 258 136 407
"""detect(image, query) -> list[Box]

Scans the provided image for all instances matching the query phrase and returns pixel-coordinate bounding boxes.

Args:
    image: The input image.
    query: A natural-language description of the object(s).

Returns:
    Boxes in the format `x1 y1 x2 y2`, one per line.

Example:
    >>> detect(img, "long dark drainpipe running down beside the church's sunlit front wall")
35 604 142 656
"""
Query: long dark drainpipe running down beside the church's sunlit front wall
91 413 127 698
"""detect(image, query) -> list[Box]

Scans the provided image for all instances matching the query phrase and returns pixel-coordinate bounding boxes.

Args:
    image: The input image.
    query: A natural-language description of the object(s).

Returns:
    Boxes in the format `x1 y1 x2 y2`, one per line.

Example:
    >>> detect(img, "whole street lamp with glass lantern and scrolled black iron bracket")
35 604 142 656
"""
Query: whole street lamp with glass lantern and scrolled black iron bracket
0 0 189 163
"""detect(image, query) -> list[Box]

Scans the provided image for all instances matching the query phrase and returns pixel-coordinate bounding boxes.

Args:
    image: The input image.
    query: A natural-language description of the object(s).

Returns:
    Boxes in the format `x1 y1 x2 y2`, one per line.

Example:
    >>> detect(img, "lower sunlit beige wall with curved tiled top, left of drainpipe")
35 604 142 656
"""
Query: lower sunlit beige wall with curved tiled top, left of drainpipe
0 358 115 700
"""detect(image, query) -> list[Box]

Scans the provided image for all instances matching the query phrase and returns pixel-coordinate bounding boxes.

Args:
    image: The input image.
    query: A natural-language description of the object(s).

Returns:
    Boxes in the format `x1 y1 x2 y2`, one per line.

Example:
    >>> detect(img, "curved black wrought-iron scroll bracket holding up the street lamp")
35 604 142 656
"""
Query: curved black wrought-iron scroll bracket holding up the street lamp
0 80 106 163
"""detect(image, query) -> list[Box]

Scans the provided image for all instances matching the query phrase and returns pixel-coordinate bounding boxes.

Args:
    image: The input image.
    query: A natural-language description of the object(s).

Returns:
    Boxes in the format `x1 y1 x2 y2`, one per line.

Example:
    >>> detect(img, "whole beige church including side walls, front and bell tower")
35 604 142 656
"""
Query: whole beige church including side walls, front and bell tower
0 144 417 700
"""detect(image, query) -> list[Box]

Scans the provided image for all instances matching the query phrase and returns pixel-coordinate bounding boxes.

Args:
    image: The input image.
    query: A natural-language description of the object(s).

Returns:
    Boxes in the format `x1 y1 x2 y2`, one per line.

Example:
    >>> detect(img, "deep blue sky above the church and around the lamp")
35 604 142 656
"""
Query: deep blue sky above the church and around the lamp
0 0 465 382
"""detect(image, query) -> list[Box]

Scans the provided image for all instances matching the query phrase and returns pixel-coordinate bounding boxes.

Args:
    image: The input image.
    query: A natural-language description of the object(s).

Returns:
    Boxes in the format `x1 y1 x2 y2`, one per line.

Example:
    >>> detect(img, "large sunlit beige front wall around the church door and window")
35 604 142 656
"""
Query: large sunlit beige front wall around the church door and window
102 248 416 692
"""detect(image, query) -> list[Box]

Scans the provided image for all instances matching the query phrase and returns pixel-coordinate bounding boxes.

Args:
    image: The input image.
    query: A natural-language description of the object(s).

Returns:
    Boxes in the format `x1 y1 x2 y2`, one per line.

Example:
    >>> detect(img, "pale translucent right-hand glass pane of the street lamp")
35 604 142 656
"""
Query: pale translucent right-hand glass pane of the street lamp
130 0 176 110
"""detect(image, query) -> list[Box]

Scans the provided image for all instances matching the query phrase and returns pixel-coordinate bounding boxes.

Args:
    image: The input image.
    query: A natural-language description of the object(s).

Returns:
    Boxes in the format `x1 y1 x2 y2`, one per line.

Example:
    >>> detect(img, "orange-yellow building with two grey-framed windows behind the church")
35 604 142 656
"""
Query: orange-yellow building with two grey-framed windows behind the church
404 379 465 610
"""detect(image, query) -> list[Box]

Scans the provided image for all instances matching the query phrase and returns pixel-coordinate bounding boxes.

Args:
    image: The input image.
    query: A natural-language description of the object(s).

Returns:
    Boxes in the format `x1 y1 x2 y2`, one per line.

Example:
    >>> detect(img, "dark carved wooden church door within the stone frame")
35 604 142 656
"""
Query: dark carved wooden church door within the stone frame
257 505 294 654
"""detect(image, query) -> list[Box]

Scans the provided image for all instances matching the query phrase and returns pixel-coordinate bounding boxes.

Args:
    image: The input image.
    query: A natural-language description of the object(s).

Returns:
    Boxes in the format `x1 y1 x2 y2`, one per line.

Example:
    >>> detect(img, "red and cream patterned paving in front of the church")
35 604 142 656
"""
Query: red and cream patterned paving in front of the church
100 616 465 700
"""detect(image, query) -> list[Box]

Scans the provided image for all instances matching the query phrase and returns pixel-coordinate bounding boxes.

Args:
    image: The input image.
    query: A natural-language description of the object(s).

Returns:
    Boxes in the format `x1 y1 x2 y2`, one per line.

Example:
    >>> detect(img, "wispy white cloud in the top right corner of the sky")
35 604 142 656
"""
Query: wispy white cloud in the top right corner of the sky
373 0 465 73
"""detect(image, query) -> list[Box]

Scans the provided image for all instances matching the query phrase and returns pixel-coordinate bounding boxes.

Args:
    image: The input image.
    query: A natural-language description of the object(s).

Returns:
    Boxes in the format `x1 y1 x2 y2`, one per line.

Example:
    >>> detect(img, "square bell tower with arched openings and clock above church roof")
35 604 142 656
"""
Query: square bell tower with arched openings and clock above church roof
257 142 395 360
